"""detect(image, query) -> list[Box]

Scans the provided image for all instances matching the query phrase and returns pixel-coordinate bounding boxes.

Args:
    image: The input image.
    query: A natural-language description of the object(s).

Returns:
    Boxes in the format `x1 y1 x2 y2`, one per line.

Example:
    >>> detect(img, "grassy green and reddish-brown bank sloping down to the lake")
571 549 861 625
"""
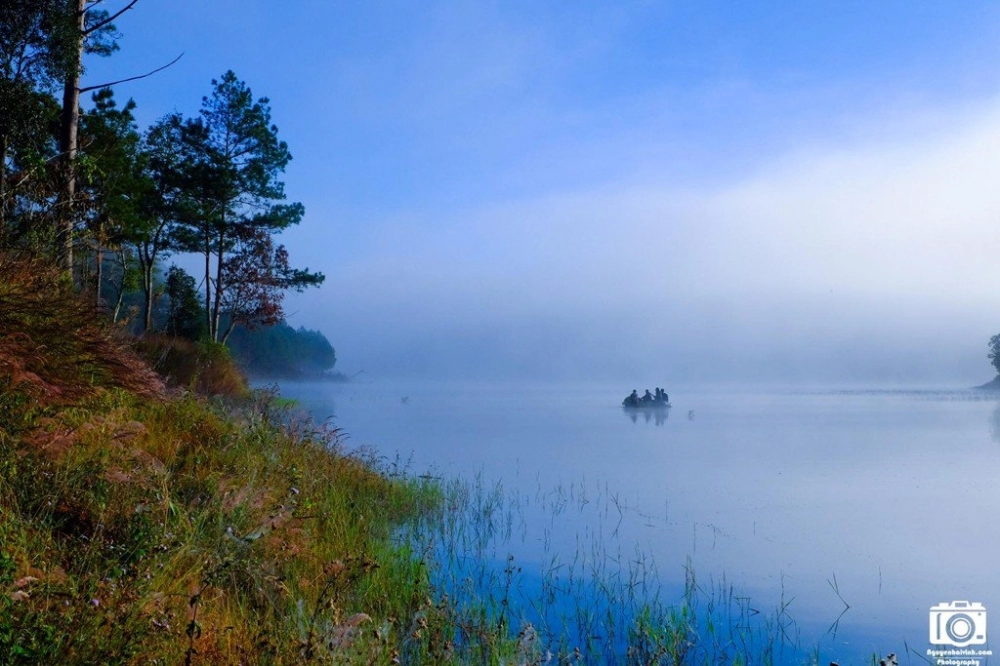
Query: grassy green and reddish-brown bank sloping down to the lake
0 256 460 664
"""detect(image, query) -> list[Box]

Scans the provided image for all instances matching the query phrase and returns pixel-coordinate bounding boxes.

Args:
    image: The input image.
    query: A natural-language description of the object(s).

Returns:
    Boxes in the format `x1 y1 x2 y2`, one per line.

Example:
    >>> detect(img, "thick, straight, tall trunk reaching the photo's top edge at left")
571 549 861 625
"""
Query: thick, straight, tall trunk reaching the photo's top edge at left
56 0 87 275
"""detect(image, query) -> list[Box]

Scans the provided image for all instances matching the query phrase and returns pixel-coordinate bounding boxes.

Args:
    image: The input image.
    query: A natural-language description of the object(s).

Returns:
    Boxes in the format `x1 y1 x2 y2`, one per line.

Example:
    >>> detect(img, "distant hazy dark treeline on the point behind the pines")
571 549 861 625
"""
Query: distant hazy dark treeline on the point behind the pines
227 322 341 379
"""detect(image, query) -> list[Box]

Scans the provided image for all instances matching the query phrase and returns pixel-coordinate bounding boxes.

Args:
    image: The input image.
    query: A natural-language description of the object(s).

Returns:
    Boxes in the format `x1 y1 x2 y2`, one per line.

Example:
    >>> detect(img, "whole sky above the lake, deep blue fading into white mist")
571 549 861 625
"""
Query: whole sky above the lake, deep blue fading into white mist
85 0 1000 383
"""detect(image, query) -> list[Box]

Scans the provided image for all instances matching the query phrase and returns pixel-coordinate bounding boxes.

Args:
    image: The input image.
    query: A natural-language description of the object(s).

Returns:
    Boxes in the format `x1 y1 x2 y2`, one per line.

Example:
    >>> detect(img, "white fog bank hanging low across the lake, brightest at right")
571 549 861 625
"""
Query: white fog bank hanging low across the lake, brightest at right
292 96 1000 379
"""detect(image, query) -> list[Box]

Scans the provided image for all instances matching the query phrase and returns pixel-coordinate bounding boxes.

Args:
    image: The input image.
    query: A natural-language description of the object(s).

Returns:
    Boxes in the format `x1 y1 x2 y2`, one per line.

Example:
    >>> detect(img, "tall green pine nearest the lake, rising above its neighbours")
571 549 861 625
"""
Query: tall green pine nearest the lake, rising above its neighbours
171 71 312 340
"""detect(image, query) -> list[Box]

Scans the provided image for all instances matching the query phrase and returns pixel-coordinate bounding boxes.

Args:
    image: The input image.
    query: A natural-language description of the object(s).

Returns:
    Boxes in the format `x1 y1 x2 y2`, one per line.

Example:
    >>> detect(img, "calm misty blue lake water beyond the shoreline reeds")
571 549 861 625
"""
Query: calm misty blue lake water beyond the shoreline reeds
274 383 1000 663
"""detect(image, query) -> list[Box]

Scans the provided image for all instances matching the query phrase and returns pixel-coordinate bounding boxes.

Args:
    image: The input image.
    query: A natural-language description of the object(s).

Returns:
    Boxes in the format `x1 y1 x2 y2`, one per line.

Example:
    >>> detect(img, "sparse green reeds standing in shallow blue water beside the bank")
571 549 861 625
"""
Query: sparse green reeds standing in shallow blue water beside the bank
397 474 856 664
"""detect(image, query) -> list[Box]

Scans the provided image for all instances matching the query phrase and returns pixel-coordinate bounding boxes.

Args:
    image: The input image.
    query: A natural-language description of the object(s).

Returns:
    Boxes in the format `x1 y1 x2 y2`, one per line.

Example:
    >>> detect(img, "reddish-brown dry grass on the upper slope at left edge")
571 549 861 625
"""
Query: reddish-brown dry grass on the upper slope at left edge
0 252 164 404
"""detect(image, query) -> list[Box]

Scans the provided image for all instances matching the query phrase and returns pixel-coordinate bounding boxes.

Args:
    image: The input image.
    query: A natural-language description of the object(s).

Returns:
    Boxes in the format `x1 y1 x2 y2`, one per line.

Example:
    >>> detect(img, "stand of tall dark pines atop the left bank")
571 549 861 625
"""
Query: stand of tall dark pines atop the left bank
0 0 324 352
